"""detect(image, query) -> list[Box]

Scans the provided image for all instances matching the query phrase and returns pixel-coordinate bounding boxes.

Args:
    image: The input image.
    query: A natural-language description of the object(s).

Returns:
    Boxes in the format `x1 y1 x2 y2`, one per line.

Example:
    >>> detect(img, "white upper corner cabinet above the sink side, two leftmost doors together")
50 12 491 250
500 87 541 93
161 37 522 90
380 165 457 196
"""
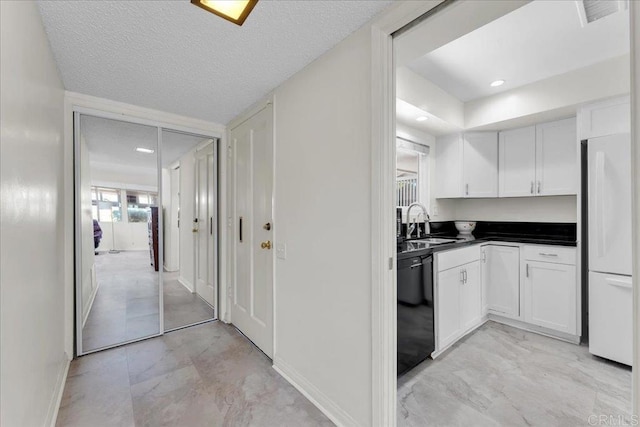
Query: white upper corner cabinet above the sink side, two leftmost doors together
436 132 498 199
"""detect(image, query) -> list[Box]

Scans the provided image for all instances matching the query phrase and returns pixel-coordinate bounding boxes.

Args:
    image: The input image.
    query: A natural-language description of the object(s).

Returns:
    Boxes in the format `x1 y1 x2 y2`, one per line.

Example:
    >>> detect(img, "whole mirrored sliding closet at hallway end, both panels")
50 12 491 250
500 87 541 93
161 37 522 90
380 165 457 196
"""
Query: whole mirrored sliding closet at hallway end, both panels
74 113 218 355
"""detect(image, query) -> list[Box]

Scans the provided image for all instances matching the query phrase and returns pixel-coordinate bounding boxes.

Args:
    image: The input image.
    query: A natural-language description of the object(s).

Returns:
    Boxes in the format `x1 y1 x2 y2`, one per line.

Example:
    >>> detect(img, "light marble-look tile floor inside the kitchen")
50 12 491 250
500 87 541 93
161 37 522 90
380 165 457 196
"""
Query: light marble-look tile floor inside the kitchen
398 322 631 427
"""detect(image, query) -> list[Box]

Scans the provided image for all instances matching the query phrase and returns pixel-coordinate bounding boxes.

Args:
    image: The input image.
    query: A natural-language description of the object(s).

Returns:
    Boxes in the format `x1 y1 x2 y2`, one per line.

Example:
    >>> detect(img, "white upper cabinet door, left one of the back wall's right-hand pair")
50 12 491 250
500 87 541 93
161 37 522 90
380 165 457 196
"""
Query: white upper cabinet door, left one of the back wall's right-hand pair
498 126 536 197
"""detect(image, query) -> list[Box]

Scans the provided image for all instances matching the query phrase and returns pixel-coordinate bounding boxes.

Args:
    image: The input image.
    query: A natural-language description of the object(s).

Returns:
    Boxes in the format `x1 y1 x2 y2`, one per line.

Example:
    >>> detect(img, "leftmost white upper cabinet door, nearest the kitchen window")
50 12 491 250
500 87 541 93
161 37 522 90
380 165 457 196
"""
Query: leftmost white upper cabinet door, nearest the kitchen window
435 134 462 199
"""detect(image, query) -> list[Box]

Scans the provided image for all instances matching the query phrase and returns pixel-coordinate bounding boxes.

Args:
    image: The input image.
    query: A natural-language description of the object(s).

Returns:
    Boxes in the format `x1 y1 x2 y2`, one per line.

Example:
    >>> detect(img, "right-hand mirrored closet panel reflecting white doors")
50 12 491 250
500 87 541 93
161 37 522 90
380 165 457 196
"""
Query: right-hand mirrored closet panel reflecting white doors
161 130 218 331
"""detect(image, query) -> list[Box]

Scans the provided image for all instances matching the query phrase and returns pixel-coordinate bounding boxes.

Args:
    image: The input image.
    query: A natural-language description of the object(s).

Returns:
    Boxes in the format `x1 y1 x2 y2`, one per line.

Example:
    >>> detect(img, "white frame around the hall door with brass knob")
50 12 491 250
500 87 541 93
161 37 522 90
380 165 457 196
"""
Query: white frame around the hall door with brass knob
225 98 278 350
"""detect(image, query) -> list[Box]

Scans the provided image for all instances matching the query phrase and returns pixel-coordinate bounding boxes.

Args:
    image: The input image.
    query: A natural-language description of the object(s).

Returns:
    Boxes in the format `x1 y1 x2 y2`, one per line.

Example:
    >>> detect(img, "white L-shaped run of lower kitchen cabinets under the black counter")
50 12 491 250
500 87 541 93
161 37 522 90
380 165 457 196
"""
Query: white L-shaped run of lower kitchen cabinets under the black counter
434 242 579 354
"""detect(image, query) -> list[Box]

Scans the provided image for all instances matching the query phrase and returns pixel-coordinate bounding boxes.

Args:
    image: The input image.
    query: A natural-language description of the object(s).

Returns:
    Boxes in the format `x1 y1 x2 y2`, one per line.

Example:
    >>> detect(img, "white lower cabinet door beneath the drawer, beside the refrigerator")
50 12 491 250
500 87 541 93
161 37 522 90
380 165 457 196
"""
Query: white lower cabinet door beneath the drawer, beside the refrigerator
524 261 578 335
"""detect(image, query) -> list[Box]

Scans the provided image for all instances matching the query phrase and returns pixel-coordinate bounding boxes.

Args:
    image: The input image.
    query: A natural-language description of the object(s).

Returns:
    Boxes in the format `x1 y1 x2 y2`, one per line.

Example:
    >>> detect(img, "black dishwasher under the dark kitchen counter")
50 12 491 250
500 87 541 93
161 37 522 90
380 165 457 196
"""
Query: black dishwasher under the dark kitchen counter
397 255 435 376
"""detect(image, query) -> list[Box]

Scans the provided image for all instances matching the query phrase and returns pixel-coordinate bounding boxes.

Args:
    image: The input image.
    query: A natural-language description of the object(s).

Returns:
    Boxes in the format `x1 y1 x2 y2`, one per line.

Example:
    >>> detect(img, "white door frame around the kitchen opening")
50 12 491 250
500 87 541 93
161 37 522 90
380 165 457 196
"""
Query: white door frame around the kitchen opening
371 0 640 427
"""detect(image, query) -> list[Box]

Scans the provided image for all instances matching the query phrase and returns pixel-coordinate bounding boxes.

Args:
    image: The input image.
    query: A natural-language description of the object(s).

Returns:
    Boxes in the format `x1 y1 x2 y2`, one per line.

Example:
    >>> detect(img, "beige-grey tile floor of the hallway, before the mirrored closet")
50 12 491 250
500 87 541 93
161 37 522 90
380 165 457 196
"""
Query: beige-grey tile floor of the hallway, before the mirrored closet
56 322 333 427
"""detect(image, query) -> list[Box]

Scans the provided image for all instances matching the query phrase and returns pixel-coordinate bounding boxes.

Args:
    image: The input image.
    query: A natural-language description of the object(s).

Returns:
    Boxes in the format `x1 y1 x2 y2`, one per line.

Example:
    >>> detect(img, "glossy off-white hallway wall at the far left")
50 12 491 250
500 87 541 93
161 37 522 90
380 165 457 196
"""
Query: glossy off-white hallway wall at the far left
0 1 67 427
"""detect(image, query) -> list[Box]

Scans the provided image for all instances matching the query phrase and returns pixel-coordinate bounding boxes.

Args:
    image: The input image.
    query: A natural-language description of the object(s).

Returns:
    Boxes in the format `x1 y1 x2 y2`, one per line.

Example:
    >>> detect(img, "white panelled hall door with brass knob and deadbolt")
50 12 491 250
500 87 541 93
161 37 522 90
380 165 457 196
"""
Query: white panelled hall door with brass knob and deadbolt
231 106 273 357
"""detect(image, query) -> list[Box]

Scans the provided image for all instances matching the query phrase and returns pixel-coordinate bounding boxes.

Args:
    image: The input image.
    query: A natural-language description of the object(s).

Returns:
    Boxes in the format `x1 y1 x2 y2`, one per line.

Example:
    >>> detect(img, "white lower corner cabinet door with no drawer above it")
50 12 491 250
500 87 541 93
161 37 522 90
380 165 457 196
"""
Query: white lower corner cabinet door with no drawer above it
482 246 520 317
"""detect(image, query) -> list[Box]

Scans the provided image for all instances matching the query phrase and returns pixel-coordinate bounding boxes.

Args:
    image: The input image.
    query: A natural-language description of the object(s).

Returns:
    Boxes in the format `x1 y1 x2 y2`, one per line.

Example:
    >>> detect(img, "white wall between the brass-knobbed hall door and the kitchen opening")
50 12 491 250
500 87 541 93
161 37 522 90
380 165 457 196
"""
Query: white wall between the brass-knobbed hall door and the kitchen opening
274 24 372 426
